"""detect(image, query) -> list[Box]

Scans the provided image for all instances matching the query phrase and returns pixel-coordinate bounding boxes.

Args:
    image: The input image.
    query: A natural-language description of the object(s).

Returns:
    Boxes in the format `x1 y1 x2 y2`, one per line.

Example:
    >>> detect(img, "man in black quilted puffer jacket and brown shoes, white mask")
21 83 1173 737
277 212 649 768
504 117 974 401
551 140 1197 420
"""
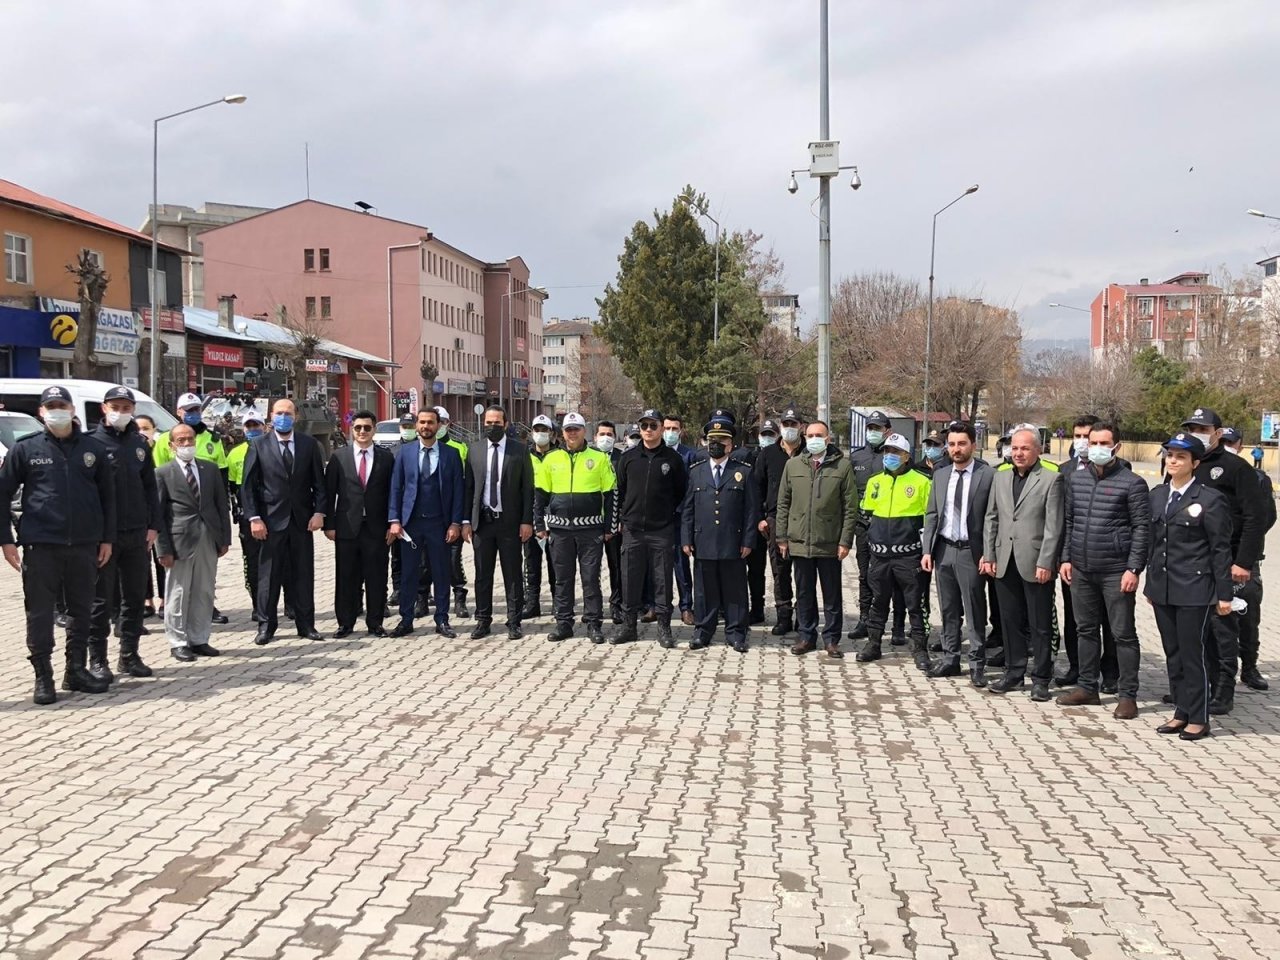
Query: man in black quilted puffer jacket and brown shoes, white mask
1057 422 1151 719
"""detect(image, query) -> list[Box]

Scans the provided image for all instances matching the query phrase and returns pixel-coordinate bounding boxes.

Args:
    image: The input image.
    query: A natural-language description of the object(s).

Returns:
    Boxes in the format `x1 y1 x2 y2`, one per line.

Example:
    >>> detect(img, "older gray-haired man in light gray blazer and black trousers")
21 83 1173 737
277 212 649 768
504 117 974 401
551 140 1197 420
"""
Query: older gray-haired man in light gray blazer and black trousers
982 429 1064 703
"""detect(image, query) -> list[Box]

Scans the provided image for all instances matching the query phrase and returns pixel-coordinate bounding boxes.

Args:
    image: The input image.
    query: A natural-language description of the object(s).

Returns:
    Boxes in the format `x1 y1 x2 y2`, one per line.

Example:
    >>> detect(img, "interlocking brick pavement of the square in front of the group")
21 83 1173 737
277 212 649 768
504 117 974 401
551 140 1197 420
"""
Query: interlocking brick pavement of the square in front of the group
0 531 1280 960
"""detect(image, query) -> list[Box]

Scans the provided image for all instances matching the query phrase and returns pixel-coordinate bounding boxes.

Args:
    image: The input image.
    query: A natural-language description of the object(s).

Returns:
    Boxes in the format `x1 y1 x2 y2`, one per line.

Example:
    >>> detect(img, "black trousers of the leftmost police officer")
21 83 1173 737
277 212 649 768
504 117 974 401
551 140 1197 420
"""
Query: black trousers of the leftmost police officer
22 544 97 664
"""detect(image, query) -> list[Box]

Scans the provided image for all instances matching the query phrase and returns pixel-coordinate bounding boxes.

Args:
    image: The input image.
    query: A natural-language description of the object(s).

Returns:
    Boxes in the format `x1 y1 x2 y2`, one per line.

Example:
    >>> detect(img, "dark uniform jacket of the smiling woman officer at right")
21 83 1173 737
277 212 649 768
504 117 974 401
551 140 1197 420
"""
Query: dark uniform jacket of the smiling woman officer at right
1144 480 1233 607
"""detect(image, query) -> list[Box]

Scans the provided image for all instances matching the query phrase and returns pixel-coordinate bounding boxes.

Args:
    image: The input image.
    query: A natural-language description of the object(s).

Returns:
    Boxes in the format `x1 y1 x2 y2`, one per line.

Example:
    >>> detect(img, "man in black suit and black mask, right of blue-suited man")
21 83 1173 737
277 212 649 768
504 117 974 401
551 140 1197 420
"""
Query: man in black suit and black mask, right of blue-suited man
462 407 534 640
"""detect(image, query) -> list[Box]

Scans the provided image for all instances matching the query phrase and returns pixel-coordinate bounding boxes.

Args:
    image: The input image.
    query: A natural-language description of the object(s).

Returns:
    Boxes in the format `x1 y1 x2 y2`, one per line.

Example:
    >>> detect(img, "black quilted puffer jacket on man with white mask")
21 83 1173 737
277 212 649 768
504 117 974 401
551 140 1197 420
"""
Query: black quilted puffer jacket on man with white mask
1062 461 1151 573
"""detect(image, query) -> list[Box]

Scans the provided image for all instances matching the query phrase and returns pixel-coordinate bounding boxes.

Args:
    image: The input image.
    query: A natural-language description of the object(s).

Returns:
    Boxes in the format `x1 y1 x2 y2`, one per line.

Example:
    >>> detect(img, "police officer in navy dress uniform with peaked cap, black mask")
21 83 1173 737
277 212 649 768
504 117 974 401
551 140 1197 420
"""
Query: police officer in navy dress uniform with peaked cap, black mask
680 411 759 653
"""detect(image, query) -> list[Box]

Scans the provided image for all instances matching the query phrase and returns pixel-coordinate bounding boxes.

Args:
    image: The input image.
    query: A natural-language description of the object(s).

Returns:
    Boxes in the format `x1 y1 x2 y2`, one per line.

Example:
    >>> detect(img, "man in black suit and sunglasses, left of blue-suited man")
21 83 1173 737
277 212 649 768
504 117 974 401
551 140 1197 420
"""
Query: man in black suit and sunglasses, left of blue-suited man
324 410 396 640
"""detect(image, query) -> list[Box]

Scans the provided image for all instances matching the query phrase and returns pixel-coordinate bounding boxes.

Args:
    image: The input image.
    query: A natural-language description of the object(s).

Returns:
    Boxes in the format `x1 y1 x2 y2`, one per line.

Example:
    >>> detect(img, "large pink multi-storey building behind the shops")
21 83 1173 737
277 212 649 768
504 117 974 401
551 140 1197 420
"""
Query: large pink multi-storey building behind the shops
201 200 545 425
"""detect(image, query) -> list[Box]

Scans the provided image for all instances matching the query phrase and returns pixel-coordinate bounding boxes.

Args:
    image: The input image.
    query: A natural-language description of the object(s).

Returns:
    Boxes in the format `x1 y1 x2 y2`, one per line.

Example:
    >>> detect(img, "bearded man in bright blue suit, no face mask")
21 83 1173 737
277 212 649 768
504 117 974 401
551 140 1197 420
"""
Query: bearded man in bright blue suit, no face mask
387 407 465 640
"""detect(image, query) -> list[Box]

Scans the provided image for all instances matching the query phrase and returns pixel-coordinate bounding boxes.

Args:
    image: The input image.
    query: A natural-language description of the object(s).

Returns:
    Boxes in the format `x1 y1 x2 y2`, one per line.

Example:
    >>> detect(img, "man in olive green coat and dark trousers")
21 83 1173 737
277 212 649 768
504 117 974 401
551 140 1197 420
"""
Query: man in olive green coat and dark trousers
777 420 858 659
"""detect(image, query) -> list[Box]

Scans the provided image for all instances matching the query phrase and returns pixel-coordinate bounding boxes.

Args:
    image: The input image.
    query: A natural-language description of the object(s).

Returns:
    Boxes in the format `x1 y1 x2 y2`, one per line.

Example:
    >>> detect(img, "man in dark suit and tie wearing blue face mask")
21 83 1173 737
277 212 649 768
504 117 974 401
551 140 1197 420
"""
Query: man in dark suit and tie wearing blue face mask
241 398 326 646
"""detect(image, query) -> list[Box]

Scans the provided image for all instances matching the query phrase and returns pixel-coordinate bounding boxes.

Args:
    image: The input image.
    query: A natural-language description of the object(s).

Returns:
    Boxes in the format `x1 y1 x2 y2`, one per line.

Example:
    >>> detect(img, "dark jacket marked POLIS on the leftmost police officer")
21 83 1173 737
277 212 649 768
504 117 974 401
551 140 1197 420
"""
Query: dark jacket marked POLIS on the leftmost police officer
0 426 116 545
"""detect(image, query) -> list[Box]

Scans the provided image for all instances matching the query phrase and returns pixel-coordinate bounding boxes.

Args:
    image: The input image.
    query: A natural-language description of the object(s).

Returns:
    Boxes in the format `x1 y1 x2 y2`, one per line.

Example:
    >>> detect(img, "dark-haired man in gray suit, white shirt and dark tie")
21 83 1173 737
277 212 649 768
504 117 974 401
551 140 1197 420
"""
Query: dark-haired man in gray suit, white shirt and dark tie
920 422 996 687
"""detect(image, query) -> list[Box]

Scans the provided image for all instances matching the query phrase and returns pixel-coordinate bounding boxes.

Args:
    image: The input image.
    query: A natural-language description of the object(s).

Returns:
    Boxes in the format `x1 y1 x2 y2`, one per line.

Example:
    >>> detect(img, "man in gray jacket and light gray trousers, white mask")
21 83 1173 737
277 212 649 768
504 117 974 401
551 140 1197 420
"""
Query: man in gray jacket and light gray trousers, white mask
156 424 232 663
